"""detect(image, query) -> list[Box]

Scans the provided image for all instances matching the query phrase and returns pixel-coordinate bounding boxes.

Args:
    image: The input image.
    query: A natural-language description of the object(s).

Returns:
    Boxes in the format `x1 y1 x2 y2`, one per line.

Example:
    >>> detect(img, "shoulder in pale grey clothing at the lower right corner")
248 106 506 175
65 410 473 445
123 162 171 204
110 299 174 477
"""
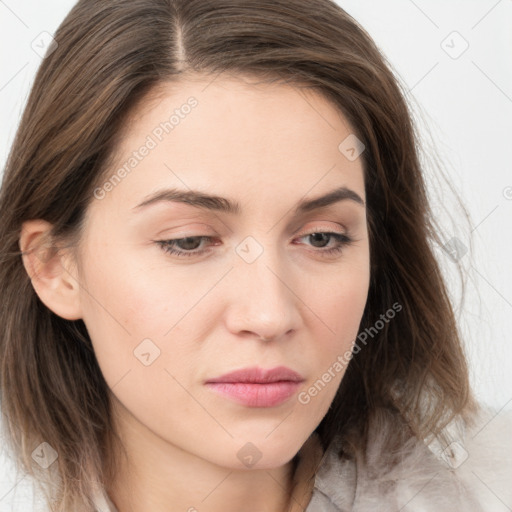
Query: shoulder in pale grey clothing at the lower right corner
307 408 512 512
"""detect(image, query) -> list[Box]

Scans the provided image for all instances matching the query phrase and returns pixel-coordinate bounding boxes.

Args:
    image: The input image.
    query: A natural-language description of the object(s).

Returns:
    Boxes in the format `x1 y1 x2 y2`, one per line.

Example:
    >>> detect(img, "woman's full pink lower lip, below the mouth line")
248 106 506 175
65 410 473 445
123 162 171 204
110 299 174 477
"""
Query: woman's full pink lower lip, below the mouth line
206 381 301 407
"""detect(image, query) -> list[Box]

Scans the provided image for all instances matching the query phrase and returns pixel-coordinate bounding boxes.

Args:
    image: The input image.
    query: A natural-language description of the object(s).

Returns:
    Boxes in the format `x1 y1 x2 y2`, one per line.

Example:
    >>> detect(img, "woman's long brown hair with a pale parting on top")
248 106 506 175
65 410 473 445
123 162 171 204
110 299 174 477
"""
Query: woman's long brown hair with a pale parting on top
0 0 474 512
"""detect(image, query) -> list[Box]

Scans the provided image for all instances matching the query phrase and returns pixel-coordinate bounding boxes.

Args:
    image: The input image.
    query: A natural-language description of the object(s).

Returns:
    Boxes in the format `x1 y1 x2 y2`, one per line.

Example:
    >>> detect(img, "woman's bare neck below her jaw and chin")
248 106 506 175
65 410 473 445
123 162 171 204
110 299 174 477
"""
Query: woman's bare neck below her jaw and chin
107 400 300 512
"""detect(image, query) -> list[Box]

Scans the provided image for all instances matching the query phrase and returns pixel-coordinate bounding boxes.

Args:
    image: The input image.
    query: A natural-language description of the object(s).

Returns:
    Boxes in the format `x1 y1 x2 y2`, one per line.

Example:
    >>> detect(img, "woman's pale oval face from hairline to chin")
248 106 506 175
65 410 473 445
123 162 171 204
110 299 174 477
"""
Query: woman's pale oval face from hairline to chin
75 74 369 468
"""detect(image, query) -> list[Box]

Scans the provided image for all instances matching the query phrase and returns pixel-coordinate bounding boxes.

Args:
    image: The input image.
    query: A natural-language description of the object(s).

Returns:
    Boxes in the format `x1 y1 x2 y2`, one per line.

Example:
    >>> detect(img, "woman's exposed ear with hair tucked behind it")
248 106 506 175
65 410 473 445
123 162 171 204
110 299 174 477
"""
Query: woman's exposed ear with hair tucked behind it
19 219 82 320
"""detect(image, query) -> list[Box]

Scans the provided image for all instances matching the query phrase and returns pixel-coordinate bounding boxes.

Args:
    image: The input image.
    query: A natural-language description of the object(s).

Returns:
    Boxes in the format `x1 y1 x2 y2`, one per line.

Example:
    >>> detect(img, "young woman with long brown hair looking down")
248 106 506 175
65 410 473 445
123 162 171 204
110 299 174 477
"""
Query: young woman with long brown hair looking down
0 0 508 512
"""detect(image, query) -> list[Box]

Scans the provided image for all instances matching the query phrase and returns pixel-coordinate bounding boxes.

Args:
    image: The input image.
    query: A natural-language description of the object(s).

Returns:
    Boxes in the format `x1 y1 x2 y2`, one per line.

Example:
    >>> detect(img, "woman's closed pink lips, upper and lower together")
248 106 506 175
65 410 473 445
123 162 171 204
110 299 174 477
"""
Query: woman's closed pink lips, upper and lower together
205 366 304 407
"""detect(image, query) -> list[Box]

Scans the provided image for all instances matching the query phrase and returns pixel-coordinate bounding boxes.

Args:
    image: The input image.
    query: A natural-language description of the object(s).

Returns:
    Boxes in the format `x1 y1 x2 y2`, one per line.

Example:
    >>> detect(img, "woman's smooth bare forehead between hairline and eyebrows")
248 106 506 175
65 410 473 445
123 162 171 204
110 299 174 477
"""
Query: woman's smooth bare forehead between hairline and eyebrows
94 77 364 214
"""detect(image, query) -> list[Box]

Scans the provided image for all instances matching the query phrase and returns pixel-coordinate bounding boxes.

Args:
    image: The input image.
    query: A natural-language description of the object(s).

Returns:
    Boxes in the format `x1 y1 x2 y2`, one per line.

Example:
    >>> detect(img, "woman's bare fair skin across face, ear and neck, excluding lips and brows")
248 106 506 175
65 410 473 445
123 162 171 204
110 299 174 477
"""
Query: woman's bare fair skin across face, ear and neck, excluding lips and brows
20 77 370 512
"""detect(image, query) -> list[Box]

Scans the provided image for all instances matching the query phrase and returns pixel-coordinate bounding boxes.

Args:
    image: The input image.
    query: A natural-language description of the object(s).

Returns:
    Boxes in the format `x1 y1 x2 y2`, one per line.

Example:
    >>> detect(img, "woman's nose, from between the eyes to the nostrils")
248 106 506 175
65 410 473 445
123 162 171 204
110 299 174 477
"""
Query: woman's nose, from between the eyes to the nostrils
226 242 301 341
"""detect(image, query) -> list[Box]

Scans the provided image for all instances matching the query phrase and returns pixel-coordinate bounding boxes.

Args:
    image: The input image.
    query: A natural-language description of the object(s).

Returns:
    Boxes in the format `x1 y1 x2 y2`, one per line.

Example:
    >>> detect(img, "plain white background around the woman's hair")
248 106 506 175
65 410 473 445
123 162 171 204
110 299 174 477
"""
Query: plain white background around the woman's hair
0 0 512 512
